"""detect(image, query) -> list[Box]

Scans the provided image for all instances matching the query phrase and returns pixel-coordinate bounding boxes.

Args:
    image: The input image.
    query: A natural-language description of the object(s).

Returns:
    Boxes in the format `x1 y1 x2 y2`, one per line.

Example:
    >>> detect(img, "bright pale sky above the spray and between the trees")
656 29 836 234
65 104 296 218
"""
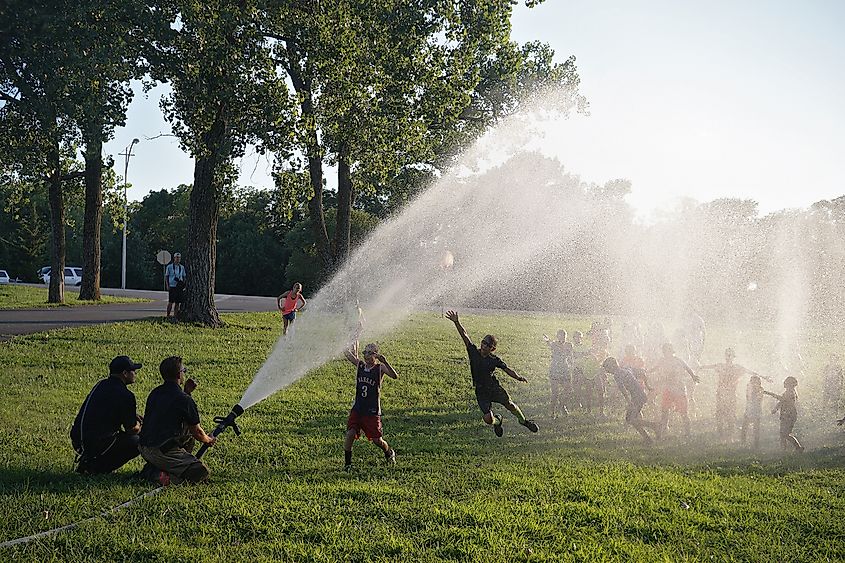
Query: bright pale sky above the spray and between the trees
106 0 845 216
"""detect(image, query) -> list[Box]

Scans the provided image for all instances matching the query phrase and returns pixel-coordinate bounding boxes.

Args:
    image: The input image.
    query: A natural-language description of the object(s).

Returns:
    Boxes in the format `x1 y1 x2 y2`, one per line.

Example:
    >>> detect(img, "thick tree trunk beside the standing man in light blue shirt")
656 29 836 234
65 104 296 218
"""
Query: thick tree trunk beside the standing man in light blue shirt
179 113 227 327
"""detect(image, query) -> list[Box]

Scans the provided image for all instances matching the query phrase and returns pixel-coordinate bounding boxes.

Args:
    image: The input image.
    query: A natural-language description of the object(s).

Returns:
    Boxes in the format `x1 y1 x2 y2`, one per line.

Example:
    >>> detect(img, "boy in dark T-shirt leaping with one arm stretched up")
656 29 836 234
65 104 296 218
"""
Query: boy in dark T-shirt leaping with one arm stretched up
446 311 539 437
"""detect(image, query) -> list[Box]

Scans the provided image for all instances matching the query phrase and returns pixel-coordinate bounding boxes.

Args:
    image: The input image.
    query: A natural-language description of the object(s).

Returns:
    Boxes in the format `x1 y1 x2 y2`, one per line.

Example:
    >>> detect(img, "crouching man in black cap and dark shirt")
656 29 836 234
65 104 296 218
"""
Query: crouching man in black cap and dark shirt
70 356 141 473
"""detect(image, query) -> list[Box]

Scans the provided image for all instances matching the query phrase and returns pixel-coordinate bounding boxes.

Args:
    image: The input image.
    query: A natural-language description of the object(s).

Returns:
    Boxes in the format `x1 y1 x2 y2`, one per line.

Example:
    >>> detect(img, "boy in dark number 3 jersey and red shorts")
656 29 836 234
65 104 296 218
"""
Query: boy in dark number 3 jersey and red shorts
343 340 399 471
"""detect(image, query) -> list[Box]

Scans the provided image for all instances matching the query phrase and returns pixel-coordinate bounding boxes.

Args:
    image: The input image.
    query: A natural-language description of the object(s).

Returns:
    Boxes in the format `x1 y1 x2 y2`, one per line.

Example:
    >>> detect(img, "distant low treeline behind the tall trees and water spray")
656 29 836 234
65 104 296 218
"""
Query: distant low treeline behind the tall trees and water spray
0 153 845 324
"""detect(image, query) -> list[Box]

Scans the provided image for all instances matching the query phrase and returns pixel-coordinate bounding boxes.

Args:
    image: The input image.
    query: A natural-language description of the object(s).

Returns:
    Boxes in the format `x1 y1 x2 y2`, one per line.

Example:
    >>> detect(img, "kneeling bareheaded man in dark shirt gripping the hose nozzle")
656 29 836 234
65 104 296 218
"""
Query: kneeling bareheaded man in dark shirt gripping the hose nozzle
138 356 216 485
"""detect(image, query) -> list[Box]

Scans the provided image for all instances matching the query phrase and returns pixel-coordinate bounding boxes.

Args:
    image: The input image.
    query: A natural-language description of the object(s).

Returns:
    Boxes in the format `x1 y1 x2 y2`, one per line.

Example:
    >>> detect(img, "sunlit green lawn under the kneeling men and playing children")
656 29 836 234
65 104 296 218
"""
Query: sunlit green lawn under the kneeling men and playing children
0 313 845 562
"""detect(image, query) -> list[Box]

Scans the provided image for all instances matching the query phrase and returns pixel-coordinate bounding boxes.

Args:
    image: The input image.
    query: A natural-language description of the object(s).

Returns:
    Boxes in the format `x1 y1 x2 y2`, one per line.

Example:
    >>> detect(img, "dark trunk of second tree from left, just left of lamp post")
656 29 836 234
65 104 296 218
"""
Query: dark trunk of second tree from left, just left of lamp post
79 132 103 300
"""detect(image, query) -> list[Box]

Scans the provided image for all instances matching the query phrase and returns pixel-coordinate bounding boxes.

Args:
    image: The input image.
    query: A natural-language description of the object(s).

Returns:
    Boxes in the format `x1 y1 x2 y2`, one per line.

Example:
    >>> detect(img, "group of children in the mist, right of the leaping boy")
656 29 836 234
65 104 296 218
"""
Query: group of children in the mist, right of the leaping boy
543 315 824 451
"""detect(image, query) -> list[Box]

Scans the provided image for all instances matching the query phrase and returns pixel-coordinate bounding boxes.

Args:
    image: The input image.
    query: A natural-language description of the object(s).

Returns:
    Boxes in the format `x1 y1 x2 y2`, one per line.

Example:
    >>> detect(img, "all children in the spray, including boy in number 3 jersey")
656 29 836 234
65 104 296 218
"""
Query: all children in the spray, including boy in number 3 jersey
330 302 845 470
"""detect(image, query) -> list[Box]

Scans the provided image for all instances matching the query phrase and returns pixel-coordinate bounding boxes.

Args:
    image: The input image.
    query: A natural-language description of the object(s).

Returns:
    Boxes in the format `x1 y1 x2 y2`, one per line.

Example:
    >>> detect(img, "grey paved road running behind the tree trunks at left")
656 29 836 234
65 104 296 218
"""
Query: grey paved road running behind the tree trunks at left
0 286 276 339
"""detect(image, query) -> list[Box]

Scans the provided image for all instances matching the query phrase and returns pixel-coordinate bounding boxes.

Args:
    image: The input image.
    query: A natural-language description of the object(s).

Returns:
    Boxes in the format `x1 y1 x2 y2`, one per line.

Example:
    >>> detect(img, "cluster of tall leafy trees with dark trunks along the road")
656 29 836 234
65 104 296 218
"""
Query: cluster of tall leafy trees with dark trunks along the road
0 0 587 326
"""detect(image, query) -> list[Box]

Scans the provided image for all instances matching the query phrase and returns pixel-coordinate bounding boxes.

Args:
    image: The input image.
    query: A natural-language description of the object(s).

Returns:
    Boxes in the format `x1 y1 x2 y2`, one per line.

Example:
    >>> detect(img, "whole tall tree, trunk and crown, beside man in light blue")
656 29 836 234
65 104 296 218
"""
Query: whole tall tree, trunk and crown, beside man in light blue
159 0 289 326
